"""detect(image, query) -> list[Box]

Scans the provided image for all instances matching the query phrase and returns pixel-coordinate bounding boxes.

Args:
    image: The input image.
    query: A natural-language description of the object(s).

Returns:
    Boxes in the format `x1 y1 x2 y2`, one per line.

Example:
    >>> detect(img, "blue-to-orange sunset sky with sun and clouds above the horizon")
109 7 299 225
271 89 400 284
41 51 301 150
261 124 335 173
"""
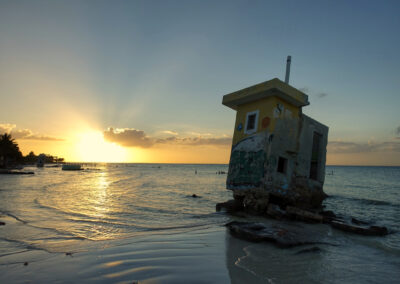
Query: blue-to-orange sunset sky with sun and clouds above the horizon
0 0 400 165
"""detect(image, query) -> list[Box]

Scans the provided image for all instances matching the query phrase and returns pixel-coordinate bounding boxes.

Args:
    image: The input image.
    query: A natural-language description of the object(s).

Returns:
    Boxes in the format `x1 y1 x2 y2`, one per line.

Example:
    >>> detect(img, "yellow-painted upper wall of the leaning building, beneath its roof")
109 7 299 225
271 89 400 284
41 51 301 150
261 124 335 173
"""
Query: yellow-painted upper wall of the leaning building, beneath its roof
232 96 300 145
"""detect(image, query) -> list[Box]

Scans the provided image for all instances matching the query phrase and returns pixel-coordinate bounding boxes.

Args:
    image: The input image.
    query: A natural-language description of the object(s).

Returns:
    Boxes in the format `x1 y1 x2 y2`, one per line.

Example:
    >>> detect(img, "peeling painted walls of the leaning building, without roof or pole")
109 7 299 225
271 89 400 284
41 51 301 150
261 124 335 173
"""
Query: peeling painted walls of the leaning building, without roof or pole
222 77 328 209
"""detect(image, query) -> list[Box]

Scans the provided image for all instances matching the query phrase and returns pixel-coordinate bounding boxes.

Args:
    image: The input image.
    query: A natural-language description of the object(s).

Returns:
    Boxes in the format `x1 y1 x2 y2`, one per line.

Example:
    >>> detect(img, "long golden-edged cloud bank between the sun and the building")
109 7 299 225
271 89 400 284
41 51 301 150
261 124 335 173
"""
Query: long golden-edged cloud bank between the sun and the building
103 128 232 148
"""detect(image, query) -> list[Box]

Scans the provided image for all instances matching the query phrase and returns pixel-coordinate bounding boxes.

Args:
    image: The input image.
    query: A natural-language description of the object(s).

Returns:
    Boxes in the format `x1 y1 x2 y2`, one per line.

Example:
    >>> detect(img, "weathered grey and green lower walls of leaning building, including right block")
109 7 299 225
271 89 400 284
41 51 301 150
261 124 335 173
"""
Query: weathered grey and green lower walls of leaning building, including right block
227 112 328 207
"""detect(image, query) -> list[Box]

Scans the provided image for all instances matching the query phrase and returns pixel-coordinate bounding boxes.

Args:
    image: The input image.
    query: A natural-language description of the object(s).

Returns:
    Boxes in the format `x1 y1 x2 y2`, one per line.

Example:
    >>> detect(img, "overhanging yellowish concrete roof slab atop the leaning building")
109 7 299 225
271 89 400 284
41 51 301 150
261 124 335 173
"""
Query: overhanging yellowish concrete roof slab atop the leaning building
222 78 310 110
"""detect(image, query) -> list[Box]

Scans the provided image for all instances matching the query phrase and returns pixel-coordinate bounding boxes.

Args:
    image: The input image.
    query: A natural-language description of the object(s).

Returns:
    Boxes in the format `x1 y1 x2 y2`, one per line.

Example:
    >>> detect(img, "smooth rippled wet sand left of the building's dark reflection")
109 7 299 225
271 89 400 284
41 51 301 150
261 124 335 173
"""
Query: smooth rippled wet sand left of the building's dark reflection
0 227 234 283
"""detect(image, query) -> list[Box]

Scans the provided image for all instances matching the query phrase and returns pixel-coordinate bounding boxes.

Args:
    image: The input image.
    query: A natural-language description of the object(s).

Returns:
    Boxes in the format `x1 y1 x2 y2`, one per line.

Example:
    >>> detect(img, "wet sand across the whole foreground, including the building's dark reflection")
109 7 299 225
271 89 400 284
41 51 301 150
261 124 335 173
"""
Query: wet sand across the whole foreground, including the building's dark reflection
0 220 400 283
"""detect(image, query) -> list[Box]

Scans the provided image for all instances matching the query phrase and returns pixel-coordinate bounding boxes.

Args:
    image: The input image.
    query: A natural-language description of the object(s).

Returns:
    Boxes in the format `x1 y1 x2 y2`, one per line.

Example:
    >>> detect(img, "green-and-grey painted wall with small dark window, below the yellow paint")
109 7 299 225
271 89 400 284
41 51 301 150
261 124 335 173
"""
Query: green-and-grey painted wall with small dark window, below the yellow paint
227 114 299 194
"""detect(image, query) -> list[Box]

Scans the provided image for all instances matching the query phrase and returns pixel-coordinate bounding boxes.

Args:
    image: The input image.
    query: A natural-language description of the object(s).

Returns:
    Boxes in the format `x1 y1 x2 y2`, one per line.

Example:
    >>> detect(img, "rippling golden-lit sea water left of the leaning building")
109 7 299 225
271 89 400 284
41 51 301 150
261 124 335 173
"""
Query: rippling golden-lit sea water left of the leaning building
0 164 229 251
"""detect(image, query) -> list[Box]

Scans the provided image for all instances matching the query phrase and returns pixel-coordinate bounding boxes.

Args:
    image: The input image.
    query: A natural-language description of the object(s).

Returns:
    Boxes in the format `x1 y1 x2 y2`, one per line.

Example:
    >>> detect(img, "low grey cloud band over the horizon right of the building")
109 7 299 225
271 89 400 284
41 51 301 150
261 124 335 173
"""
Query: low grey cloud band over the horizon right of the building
328 141 400 153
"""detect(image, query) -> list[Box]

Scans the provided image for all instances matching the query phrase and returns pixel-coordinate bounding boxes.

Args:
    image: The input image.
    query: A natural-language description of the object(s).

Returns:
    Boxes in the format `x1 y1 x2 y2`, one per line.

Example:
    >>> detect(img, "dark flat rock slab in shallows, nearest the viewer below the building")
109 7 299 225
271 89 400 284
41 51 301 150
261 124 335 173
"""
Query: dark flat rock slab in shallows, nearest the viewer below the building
226 221 321 248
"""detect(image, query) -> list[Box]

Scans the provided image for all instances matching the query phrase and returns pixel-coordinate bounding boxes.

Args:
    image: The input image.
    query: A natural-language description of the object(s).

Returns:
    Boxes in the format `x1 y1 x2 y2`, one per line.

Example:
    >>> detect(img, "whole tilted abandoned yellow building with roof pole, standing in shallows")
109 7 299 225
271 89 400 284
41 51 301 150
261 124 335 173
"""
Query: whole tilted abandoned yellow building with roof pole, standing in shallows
222 56 328 211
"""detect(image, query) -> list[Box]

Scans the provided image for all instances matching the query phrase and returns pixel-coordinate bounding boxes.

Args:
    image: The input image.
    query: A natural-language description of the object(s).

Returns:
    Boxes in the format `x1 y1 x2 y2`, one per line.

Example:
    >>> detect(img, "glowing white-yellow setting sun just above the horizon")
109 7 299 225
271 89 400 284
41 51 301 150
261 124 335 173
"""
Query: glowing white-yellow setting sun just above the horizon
75 130 128 163
